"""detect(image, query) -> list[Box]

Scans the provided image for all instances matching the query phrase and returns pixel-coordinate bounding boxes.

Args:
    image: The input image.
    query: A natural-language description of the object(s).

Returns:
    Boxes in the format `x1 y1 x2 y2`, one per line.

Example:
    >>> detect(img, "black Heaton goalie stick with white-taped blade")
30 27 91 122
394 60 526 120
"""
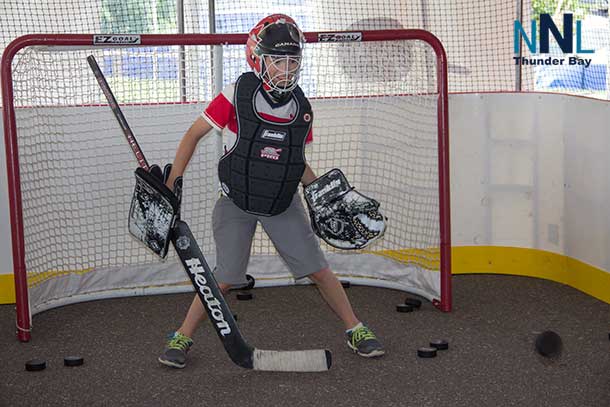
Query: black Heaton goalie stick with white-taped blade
87 55 332 372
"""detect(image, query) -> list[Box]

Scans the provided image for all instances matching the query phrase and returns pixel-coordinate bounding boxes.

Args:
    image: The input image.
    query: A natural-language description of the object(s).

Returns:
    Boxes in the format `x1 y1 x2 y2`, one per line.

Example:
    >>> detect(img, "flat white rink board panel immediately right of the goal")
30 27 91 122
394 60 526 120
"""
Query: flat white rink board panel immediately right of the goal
449 94 564 253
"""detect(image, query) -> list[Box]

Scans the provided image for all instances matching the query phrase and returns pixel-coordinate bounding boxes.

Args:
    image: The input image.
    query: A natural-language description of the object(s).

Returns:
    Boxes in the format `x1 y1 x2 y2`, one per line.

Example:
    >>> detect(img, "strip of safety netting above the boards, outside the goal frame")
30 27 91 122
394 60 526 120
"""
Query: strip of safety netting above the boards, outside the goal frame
0 0 610 99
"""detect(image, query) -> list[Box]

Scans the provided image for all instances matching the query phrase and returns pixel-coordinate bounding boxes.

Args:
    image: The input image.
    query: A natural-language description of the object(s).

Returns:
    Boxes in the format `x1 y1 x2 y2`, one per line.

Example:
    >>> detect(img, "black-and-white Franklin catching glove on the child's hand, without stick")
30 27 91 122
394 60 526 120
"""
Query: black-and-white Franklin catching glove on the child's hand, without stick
303 168 386 249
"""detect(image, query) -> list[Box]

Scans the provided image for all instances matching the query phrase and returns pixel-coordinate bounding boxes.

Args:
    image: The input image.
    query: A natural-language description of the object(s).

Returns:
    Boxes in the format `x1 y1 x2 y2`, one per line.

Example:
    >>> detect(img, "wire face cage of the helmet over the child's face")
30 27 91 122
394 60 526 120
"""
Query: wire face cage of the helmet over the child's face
261 55 301 92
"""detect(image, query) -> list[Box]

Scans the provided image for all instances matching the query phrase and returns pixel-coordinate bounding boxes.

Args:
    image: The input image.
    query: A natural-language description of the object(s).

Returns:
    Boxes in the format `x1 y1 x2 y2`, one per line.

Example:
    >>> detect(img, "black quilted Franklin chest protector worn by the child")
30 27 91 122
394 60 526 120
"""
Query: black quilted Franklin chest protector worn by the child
218 72 313 216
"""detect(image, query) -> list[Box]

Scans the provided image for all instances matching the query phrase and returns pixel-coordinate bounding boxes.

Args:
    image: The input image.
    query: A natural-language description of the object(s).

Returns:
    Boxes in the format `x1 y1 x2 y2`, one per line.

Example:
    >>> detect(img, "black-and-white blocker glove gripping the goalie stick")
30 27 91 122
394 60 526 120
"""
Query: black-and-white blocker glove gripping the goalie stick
128 164 182 258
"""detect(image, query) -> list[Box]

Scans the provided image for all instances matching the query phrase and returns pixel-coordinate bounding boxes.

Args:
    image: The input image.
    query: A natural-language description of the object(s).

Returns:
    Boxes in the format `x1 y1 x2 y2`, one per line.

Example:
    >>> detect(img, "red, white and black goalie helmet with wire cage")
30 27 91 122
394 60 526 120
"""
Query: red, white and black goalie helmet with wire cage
246 14 304 96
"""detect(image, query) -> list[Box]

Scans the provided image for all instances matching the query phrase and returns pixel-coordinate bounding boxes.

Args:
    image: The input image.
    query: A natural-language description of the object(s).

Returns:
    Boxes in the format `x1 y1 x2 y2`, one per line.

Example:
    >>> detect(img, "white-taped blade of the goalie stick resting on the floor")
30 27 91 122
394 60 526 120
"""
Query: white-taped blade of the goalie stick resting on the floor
253 349 332 372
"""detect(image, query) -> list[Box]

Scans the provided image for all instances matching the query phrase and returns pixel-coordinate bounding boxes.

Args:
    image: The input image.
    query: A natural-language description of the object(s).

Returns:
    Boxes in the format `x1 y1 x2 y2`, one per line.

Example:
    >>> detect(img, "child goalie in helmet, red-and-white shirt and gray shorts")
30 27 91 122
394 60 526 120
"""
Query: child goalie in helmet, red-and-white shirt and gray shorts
159 14 385 368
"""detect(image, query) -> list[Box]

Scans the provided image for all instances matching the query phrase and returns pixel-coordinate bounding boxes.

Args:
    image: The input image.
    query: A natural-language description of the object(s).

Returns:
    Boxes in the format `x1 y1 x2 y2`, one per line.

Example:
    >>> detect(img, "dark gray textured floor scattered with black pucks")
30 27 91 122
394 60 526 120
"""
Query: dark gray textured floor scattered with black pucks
0 275 610 407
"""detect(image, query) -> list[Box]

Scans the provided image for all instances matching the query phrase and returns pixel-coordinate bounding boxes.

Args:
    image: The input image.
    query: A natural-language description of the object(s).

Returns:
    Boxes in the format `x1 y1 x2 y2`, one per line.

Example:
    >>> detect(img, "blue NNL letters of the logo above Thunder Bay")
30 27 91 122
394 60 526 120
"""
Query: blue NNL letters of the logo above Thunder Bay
513 14 595 54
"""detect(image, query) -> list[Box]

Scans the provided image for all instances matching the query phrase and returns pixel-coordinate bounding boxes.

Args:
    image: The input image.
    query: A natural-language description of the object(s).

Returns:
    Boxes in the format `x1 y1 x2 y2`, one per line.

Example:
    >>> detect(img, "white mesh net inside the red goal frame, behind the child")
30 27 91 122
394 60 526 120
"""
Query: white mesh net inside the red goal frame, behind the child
7 35 440 312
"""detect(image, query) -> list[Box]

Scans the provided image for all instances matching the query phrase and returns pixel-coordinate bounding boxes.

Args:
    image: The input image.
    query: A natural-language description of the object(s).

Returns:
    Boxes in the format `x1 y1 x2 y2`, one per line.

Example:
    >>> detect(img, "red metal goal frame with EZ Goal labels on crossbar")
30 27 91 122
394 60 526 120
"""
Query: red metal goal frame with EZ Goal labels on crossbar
1 29 451 341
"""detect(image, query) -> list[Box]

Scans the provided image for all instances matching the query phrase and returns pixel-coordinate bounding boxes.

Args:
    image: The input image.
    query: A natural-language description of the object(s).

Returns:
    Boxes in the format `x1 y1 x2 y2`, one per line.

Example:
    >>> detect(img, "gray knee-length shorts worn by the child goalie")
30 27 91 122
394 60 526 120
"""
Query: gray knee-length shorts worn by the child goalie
212 194 328 285
